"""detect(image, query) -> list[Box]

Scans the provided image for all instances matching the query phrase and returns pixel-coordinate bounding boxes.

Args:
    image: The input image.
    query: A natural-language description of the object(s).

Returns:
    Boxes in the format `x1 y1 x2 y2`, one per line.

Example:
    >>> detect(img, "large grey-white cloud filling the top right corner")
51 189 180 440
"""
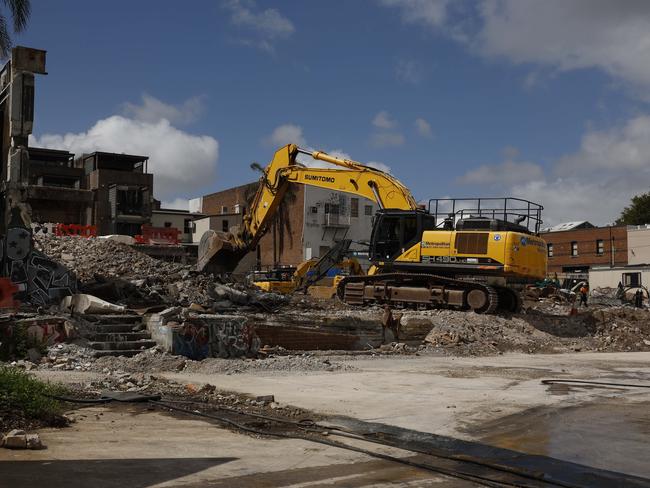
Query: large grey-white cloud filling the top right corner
381 0 650 98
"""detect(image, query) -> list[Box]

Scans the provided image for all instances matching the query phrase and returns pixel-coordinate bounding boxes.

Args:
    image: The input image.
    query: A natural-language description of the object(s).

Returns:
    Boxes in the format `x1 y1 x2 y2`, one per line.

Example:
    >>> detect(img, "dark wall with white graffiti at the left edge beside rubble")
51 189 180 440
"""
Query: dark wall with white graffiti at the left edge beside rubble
3 207 77 305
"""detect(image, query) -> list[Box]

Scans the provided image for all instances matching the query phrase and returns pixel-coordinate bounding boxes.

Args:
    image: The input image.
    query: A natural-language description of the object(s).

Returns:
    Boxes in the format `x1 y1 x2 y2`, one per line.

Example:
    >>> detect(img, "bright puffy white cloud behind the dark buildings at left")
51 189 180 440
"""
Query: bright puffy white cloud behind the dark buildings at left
30 115 219 200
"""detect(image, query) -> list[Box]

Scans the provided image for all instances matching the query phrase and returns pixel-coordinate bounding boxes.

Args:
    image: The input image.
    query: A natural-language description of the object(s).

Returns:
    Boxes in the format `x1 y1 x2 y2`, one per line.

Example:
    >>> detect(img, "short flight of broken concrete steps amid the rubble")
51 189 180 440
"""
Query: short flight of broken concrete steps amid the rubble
86 315 156 357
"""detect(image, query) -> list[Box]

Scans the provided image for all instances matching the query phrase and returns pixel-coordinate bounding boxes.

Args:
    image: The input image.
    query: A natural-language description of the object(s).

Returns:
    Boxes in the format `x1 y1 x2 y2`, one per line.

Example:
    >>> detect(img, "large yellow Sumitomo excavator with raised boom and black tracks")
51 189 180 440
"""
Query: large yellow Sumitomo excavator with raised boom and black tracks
198 144 547 313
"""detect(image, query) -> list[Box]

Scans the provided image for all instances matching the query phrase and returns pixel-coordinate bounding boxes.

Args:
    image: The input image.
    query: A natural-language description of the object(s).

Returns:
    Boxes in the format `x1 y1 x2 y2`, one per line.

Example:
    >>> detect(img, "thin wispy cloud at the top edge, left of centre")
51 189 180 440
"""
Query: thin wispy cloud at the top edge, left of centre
223 0 296 52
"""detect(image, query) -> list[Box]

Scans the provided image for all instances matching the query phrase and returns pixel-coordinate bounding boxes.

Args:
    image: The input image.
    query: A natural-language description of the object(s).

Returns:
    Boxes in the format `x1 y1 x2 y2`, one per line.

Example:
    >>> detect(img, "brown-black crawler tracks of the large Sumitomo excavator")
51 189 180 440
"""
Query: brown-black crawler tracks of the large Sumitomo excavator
336 273 521 314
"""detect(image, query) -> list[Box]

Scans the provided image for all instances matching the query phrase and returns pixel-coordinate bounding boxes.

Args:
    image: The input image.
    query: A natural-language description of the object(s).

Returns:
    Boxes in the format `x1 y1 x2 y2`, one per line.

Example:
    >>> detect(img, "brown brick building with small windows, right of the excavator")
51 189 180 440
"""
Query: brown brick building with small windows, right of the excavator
541 226 628 274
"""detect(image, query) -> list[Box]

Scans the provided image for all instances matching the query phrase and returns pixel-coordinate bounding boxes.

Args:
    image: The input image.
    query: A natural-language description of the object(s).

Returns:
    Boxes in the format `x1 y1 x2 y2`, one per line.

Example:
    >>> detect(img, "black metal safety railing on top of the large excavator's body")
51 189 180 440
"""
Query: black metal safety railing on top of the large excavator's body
429 197 544 234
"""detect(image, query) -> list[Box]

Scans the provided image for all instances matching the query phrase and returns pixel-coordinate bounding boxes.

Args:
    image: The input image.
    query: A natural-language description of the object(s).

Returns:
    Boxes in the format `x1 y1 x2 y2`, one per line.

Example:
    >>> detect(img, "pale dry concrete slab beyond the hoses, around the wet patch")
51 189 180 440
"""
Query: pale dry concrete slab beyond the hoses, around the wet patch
157 353 650 477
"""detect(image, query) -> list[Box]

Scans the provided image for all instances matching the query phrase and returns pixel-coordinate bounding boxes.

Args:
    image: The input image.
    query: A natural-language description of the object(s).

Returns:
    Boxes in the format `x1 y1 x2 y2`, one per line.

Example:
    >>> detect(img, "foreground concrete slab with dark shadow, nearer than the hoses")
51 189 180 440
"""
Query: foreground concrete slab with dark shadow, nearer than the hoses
0 405 460 488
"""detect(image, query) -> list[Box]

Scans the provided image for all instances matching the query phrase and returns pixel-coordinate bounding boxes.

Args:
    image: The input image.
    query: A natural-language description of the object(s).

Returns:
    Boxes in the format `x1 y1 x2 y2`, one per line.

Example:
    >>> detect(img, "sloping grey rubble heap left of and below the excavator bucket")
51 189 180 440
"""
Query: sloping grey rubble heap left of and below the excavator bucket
34 235 286 311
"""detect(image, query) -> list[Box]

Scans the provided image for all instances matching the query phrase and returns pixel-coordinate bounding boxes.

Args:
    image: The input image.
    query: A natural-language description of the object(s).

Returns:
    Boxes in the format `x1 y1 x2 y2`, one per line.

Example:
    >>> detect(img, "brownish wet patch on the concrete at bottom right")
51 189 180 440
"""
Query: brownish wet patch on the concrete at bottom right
479 402 650 478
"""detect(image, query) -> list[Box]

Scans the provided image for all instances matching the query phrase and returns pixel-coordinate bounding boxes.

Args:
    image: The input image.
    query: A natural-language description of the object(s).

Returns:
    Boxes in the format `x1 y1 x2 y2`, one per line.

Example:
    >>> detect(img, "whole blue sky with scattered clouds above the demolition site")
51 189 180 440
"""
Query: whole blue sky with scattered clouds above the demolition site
15 0 650 224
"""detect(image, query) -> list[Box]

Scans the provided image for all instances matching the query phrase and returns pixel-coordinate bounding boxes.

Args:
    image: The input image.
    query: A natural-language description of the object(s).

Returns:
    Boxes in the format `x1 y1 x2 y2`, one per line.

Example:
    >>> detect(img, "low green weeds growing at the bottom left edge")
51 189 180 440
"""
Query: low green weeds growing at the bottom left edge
0 365 65 419
